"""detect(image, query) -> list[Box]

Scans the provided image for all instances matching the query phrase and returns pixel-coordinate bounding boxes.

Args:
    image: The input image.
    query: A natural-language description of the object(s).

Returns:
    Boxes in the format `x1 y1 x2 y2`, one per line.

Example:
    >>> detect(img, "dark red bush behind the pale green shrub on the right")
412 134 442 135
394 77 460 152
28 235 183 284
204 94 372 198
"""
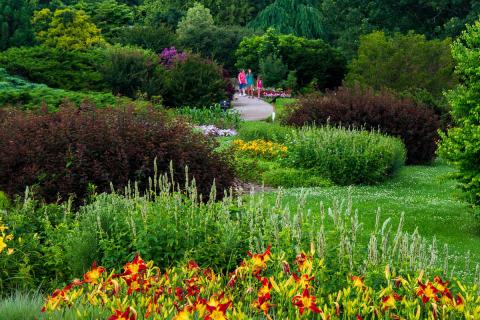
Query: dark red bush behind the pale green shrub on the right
284 87 440 164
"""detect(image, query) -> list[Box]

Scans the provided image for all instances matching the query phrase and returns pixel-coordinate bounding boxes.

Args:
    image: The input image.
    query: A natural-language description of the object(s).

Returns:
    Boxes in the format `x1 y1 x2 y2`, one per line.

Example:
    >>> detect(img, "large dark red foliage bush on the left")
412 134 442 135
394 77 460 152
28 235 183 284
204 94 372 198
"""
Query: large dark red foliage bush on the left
0 104 234 202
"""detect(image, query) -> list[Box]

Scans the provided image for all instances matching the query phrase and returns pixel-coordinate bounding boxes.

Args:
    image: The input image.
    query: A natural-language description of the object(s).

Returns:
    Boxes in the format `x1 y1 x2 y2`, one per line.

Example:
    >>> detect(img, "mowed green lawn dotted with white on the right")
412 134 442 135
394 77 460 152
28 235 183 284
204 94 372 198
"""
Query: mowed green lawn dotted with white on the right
256 163 480 277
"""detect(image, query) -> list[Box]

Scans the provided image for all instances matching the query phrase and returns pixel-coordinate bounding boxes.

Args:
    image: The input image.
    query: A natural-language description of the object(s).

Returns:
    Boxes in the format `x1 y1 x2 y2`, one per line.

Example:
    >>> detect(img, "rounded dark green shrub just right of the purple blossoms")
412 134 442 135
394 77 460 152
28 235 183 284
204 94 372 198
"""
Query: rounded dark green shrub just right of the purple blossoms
163 54 227 108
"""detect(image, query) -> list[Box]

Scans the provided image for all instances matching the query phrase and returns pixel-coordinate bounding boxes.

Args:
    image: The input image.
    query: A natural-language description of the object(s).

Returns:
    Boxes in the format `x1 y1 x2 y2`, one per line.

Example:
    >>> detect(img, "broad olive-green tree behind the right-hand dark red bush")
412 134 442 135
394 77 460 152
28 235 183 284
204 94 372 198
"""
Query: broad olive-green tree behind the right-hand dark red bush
347 31 457 98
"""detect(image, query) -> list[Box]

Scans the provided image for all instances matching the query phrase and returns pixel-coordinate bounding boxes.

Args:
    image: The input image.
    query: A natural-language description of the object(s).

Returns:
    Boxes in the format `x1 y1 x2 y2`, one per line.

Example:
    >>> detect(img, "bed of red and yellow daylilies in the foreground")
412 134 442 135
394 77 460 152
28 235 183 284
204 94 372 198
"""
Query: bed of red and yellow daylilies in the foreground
42 246 480 320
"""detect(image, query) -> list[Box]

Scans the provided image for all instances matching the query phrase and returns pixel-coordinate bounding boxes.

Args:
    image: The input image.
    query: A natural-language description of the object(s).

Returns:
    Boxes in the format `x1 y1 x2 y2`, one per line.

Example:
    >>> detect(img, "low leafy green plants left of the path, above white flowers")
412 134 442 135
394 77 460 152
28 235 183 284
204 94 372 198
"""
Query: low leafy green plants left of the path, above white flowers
175 104 242 129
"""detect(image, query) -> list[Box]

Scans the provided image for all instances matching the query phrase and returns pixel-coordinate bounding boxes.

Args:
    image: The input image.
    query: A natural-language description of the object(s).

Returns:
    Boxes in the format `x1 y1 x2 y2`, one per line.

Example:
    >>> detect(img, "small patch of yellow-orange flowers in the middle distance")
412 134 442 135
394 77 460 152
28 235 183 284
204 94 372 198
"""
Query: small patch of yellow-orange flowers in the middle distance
232 139 288 159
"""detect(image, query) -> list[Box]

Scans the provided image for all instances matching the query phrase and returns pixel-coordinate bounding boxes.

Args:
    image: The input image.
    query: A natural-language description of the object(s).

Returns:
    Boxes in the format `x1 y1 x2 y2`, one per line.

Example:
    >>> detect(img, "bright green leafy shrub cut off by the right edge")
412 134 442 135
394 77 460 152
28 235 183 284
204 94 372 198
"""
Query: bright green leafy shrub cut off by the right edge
439 21 480 206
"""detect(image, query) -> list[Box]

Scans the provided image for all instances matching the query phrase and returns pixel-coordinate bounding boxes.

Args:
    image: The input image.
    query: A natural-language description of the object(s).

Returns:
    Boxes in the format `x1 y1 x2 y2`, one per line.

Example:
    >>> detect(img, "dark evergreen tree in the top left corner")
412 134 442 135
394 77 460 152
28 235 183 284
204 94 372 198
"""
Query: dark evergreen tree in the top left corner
0 0 33 50
